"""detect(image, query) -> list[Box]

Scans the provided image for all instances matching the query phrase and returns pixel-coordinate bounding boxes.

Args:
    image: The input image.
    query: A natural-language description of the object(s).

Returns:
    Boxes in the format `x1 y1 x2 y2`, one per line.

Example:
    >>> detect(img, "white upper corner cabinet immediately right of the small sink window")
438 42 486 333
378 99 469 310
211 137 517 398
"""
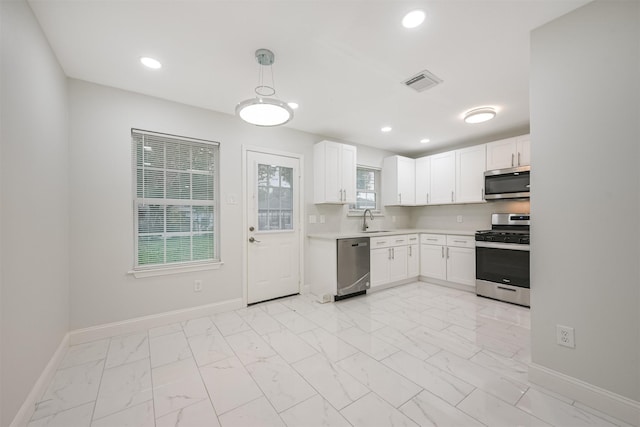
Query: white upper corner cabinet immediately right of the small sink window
382 156 416 206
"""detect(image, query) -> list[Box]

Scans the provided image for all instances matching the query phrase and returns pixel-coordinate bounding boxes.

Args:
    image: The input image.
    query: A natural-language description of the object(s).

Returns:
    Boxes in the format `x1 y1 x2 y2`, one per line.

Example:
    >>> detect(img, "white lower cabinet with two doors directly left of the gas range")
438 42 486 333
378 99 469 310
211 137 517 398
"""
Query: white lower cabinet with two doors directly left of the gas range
420 234 476 287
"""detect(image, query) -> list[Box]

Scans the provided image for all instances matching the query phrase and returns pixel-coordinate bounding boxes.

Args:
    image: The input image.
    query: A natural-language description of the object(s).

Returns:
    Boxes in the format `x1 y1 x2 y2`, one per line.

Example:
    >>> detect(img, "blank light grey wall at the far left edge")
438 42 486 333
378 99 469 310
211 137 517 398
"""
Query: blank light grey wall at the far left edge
0 1 69 426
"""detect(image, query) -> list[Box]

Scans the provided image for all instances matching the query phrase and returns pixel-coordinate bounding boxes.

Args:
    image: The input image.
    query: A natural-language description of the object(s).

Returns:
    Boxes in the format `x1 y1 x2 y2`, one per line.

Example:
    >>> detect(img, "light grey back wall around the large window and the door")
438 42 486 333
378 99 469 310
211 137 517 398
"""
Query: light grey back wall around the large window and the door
69 80 396 329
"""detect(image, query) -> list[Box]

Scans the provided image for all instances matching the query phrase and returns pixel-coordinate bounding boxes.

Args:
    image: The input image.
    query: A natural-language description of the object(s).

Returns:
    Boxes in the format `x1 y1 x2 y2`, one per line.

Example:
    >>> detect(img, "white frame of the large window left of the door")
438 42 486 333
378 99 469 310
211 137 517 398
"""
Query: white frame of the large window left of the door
129 128 222 277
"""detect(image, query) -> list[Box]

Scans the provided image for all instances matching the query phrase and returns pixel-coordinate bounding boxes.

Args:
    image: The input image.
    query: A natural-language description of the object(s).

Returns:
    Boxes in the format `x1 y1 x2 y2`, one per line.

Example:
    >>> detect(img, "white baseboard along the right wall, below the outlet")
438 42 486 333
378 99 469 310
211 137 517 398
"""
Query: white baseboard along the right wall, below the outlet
529 363 640 426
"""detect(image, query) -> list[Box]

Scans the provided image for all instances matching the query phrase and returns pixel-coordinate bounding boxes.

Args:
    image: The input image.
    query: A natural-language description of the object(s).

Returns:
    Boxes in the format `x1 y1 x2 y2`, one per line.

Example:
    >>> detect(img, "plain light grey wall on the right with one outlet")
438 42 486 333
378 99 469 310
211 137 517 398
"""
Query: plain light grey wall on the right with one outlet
530 1 640 404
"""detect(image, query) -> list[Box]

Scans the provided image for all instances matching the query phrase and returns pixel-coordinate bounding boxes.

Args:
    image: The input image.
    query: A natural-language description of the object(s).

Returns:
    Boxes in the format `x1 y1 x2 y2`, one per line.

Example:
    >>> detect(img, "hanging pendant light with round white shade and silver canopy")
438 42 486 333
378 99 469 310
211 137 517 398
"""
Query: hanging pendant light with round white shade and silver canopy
236 49 293 126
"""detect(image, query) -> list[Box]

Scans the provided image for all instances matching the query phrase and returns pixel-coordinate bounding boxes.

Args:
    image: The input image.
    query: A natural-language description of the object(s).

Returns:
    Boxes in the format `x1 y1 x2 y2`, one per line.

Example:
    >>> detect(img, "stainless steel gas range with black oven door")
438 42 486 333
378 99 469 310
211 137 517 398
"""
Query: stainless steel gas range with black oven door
476 213 531 307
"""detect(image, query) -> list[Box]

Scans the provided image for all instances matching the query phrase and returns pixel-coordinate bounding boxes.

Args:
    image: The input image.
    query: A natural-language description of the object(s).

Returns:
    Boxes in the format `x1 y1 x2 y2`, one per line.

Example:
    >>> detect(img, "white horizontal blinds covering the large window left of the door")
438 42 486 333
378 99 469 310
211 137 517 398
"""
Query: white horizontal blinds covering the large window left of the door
131 129 219 268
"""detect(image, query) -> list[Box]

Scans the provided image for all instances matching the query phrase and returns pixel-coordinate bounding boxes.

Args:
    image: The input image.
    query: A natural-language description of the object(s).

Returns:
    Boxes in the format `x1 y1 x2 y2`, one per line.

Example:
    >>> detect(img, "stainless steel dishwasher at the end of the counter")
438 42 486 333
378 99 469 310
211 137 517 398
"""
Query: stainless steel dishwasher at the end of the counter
335 237 371 300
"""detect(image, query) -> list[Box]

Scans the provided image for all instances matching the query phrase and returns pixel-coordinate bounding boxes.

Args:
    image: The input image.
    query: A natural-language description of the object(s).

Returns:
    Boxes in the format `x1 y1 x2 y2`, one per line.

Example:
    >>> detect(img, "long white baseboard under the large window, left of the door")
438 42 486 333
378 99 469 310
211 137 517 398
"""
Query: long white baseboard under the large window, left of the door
69 298 245 345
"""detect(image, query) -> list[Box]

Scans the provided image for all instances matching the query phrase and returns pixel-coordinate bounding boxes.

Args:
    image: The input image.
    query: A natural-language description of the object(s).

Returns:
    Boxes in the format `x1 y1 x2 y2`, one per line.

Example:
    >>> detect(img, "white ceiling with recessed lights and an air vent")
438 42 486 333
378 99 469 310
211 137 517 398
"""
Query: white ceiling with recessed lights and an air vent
29 0 587 155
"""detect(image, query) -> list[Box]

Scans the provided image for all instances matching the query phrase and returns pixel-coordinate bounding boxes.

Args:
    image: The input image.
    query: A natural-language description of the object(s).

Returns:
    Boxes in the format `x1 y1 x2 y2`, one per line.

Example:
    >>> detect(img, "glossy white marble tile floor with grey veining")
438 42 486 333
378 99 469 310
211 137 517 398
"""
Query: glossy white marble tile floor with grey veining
28 283 625 427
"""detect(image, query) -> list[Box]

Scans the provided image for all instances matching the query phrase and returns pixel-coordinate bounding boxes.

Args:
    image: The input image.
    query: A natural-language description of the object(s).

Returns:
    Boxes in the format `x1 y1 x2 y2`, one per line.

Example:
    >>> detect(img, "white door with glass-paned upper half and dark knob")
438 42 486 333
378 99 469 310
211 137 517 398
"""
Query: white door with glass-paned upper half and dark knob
246 151 301 304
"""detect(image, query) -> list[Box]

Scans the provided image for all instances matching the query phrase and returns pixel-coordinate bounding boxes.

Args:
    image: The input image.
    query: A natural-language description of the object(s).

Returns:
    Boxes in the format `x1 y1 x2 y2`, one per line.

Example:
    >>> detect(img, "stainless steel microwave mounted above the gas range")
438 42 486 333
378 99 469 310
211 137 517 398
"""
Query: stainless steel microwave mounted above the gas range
484 166 531 200
